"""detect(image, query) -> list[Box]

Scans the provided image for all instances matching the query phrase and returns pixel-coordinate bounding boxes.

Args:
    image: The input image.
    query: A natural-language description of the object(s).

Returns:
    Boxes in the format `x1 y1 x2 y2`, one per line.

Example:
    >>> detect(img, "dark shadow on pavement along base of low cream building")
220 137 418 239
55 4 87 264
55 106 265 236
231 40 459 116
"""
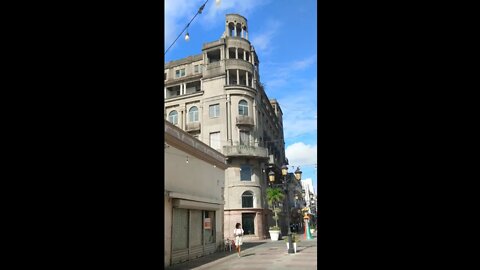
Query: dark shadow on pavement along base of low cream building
165 241 265 270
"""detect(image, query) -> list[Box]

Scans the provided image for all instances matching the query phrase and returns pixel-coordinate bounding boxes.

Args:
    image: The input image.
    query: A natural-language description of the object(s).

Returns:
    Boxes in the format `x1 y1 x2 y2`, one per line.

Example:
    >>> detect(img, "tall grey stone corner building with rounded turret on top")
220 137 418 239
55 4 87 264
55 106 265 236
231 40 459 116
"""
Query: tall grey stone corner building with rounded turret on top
164 14 288 239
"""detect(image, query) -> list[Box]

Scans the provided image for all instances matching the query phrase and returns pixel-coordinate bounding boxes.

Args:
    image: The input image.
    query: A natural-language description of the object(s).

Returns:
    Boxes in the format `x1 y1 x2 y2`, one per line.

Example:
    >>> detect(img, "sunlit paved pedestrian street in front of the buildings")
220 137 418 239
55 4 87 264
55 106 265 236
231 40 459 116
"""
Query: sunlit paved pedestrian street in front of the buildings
165 234 317 270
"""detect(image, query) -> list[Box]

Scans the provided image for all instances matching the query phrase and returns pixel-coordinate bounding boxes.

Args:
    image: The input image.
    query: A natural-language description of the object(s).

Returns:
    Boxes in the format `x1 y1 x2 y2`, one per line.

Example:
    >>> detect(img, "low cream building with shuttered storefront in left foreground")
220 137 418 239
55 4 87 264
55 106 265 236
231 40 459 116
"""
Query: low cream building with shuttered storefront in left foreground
165 122 227 266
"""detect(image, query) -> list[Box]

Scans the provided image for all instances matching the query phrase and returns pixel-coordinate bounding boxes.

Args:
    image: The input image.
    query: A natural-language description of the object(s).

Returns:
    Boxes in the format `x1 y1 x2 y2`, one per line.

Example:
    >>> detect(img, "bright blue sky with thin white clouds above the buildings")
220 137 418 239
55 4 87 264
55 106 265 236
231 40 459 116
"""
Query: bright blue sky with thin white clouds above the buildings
165 0 317 194
